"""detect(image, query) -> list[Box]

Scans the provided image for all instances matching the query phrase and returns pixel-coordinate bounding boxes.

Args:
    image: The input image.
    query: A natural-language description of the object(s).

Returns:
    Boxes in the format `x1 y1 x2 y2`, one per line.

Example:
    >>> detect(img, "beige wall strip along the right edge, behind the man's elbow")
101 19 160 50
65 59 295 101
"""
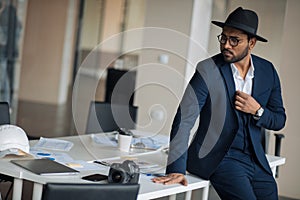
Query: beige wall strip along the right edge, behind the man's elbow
278 0 300 199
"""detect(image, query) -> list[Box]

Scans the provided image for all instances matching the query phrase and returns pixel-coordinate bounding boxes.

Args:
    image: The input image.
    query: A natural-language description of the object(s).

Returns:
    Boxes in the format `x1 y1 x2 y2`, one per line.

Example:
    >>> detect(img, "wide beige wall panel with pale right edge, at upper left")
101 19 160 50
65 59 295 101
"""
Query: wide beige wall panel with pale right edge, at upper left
19 0 78 104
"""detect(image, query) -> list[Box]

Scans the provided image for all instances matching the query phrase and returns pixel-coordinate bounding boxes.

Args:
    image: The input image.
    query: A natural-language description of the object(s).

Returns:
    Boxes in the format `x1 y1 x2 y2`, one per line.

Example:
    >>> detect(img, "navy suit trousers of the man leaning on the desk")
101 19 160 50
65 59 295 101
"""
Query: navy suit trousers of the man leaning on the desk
210 149 278 200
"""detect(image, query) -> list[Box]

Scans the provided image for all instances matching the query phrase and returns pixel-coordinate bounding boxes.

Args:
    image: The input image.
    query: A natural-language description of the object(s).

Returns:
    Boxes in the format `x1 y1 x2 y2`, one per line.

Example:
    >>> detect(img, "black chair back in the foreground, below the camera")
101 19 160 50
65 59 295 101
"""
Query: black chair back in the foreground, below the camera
42 183 139 200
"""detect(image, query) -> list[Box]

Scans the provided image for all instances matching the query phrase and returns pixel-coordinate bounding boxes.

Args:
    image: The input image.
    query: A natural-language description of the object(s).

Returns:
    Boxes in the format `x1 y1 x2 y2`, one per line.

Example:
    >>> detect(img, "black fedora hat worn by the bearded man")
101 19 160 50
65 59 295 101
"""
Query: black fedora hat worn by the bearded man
212 7 268 42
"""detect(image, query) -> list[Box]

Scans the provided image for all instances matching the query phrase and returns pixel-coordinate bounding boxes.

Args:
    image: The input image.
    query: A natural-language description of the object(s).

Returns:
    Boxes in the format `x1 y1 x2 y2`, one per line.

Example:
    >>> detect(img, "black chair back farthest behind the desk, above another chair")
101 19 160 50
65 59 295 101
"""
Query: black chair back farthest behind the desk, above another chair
105 68 136 105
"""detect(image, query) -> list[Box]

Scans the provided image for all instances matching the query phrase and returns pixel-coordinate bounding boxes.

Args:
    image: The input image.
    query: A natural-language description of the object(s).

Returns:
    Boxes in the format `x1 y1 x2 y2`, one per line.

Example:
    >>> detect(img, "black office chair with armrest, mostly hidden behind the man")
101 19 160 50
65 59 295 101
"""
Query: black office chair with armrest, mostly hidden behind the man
261 128 284 178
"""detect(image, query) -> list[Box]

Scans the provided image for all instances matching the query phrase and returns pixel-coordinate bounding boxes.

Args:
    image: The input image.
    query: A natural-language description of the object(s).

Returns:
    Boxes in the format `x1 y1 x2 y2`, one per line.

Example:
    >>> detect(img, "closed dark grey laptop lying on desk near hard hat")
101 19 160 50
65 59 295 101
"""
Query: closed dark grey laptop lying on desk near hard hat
11 159 79 176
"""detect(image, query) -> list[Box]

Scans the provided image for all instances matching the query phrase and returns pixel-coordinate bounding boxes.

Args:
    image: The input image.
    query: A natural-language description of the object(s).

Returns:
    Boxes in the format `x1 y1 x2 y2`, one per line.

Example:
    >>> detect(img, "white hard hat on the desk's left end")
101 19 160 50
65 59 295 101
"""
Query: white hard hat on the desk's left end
0 124 29 157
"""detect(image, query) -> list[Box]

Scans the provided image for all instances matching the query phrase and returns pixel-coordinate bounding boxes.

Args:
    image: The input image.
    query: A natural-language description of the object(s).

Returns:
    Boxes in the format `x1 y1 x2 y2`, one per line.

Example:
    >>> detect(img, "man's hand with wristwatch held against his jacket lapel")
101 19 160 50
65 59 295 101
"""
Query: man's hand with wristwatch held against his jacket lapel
234 91 260 115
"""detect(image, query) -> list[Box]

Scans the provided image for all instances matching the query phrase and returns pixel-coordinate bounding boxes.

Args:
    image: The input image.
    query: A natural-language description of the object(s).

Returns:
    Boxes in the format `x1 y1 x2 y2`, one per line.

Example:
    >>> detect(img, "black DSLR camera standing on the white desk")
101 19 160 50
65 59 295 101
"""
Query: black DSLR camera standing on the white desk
108 160 140 184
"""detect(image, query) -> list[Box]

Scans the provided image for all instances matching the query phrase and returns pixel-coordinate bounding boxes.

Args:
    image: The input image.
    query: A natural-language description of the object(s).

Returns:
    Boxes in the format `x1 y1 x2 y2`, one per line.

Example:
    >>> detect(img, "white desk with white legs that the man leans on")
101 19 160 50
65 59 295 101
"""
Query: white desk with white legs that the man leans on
0 135 285 200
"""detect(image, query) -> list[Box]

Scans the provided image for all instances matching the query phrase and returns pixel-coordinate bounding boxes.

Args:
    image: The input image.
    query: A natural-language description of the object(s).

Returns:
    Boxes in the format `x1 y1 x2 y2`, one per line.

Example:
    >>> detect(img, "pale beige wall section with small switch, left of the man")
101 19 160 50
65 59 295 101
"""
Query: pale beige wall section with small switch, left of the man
135 0 193 134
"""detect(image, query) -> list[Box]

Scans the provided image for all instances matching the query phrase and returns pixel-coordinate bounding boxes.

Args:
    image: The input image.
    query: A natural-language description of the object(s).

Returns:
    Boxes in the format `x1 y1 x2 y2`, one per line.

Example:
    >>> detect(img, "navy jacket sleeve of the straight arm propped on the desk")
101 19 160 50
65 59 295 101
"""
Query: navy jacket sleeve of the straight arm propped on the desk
166 69 208 174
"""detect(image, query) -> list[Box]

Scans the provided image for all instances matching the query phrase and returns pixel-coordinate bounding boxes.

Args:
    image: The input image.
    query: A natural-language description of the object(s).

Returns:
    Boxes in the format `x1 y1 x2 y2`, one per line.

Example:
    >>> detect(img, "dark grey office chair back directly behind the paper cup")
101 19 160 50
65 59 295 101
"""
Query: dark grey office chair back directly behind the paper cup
86 101 138 133
